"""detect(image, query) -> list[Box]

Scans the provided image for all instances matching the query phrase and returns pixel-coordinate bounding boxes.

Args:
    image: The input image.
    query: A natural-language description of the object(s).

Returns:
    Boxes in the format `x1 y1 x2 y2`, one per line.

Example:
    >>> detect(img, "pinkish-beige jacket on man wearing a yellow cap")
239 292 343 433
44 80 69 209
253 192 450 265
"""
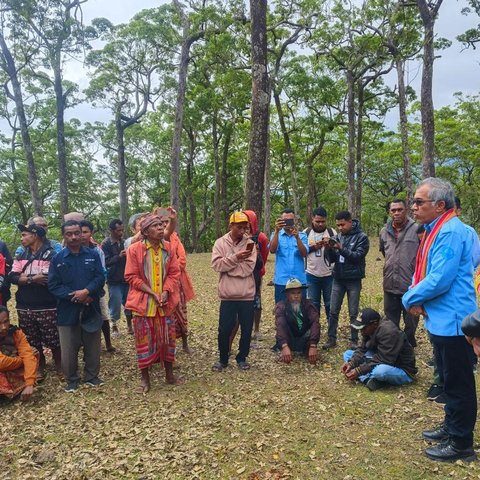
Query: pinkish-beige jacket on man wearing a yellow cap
212 233 257 300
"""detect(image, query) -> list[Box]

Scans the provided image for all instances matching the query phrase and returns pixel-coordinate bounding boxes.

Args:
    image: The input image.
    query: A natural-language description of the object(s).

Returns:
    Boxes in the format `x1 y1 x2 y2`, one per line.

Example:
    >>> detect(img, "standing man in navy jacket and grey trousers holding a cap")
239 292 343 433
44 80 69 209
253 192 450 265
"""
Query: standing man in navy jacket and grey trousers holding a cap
48 220 105 393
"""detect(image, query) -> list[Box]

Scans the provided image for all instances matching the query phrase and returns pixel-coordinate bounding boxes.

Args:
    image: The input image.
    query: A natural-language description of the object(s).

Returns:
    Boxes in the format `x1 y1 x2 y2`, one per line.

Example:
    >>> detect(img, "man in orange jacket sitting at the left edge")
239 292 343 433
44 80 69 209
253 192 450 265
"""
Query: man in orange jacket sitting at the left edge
0 305 38 401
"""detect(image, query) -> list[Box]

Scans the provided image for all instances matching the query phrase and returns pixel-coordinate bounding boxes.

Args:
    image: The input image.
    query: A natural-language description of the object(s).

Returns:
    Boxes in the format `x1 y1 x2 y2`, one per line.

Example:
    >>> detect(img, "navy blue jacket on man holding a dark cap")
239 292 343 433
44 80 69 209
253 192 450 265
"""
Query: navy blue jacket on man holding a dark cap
48 246 105 326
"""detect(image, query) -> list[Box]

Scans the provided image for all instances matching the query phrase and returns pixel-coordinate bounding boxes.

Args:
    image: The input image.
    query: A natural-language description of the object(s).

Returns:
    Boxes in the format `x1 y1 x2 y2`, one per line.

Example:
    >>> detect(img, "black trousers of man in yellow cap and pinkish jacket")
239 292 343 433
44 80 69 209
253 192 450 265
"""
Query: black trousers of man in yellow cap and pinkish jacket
218 300 253 365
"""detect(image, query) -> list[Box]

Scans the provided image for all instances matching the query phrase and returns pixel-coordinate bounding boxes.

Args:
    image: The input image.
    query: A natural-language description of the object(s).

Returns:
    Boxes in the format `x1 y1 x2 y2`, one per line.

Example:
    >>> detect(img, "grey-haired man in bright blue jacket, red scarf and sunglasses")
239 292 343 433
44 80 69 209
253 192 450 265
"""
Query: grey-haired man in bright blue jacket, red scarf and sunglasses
402 178 477 462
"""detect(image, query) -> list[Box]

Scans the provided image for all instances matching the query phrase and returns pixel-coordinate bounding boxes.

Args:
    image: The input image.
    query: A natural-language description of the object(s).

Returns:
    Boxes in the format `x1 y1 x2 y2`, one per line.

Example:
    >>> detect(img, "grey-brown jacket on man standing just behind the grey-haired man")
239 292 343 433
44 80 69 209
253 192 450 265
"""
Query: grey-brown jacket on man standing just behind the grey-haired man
380 218 420 295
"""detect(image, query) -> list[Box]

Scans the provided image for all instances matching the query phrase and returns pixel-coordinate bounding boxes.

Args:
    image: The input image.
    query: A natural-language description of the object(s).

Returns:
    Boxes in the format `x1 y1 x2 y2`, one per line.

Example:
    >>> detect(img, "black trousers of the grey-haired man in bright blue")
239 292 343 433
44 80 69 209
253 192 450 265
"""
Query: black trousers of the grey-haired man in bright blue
430 334 477 448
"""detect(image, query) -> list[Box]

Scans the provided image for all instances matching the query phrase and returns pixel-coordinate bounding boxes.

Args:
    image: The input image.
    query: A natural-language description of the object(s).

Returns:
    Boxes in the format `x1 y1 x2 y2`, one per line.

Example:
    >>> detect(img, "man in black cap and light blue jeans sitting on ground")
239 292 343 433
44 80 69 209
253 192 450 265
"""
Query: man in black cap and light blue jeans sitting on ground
342 308 417 391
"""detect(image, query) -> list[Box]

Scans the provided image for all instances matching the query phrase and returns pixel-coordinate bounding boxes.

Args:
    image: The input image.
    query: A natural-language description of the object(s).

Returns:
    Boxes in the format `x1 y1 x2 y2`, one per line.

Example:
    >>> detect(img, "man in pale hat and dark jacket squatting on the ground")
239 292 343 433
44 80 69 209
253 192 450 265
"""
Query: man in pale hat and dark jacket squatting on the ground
275 278 320 364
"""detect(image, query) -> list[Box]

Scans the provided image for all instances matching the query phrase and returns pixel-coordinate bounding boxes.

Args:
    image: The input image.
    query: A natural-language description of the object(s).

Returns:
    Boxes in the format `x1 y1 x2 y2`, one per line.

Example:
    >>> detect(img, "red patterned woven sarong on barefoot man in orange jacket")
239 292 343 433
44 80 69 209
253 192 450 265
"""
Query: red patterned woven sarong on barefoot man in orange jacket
133 310 175 369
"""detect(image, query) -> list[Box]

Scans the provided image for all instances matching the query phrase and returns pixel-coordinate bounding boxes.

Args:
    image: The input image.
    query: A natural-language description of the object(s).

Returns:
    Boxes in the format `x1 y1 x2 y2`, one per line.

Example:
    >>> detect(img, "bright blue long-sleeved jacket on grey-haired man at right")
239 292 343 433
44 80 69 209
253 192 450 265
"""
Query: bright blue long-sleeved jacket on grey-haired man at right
402 217 477 337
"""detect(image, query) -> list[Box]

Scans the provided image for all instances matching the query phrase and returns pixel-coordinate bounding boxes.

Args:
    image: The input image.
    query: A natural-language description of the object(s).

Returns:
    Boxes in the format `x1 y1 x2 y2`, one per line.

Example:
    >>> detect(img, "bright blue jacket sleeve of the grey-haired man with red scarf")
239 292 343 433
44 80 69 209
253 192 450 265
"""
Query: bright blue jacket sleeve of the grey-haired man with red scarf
402 231 463 309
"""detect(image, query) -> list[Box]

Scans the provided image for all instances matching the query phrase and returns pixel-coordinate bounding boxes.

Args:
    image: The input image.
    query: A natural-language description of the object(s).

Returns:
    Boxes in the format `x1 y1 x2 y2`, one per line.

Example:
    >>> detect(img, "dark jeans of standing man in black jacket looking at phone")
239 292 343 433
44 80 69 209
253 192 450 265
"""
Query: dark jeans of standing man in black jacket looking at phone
328 278 362 342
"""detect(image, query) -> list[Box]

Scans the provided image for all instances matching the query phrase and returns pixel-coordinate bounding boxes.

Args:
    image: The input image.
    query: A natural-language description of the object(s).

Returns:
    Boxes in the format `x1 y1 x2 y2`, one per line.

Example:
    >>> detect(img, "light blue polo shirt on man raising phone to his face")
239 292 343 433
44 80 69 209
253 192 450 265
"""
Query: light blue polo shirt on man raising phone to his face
269 228 308 285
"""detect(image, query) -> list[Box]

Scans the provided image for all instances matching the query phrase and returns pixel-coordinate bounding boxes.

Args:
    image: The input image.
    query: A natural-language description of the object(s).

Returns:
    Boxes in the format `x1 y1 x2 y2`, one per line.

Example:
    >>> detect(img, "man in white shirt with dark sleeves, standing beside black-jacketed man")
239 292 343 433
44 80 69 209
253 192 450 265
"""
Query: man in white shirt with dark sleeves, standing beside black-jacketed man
304 207 337 320
